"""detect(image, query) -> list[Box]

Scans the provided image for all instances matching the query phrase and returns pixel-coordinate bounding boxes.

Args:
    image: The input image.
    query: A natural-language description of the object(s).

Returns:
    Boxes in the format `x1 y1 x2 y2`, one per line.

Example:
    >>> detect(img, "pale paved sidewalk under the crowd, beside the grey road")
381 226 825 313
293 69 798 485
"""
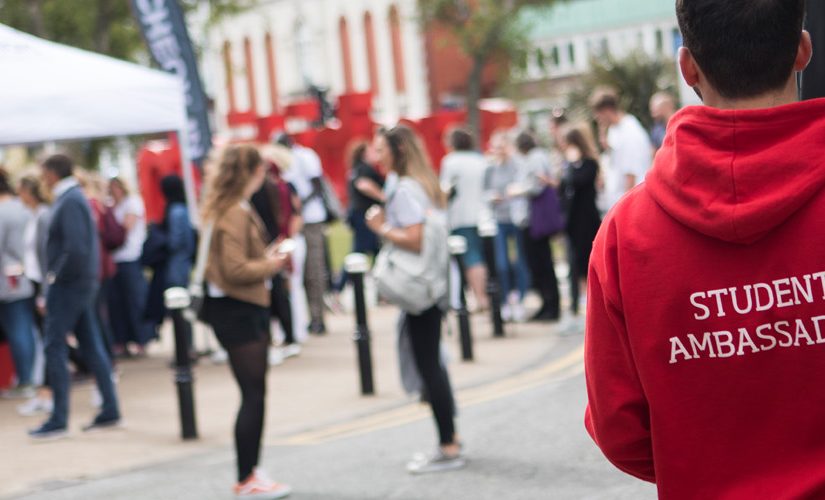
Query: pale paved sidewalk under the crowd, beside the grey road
0 298 580 496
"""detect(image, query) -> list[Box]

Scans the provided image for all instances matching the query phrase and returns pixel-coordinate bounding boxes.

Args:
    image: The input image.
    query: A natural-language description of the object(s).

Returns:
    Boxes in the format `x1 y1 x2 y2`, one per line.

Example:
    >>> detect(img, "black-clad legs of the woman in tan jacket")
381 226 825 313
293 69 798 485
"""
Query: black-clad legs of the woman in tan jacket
227 340 269 482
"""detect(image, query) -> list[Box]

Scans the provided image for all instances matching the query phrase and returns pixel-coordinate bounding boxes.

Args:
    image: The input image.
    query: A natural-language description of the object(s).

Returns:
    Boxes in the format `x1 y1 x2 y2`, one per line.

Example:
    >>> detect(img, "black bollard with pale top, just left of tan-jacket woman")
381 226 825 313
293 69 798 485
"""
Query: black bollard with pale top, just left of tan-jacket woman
164 288 198 440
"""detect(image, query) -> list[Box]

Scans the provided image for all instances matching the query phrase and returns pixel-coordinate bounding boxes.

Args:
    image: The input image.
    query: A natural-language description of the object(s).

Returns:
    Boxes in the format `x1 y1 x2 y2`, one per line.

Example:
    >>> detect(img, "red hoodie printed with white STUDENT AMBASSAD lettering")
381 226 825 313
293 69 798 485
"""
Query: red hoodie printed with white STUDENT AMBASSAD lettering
585 100 825 500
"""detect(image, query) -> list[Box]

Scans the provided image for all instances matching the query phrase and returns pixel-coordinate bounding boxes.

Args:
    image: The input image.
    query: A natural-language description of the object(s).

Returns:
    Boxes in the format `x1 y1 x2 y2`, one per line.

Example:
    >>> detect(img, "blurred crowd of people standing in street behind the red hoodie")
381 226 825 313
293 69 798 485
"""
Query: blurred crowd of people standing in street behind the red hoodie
0 83 664 498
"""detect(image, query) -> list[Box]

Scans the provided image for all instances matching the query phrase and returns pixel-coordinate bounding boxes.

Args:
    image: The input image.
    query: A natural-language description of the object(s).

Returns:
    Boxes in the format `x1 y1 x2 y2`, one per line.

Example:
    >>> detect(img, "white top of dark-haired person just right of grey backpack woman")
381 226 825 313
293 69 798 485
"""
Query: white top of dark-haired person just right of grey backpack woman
441 151 487 229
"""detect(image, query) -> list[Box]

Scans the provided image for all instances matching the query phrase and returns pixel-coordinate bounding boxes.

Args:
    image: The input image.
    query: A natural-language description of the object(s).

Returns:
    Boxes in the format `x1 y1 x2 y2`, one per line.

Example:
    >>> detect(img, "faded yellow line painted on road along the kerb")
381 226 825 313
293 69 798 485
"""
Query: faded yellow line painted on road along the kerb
284 344 584 446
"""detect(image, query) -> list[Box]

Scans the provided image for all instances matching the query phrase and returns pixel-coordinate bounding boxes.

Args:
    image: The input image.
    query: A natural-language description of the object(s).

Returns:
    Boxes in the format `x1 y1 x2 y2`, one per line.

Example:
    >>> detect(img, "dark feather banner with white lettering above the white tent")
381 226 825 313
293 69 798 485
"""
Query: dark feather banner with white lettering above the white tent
132 0 212 165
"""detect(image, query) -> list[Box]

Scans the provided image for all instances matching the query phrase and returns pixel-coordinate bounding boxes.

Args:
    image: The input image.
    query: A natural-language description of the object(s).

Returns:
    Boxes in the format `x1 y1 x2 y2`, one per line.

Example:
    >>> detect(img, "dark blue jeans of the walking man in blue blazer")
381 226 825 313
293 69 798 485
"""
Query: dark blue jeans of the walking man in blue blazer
44 283 120 428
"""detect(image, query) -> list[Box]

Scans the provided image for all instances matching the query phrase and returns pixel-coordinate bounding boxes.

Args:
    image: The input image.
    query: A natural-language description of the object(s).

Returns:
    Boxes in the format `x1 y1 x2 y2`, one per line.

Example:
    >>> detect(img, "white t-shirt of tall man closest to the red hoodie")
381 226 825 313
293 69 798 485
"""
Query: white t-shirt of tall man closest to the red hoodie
603 114 653 209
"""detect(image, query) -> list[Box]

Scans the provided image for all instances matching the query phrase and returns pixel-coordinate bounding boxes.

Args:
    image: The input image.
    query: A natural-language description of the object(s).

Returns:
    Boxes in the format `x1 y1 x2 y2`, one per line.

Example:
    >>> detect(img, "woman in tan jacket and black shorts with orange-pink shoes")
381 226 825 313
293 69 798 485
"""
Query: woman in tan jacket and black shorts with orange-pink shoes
204 146 290 498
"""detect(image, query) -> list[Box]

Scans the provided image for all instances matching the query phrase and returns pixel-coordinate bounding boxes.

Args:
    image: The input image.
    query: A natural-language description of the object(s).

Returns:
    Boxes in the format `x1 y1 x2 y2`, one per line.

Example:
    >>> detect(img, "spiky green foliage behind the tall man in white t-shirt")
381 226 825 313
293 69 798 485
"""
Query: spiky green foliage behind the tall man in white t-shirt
569 51 678 127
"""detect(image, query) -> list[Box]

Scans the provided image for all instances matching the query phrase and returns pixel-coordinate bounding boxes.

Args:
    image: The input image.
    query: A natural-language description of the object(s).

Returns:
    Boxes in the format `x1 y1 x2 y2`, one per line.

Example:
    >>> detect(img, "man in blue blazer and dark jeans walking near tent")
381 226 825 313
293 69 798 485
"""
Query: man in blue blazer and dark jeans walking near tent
29 155 121 440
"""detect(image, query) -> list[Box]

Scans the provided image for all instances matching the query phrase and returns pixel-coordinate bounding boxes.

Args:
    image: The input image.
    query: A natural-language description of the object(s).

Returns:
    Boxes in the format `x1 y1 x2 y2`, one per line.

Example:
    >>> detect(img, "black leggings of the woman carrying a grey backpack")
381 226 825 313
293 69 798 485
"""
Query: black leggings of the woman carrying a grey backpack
407 306 455 445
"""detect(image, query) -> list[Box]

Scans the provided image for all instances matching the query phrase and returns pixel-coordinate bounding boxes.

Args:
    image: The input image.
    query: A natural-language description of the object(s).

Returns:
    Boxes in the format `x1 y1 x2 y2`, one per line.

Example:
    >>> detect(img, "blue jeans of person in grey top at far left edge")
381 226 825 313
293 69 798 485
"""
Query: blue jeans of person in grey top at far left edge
0 299 35 385
